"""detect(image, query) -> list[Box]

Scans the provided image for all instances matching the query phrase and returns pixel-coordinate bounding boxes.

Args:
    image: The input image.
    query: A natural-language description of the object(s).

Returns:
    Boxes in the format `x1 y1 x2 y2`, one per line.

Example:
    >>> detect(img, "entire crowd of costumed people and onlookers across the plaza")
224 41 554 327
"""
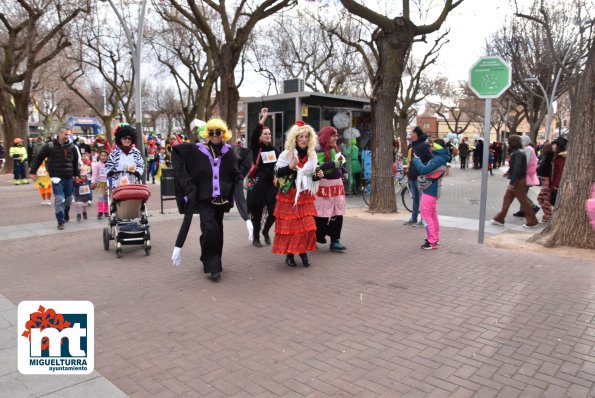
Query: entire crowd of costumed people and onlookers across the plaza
4 115 584 281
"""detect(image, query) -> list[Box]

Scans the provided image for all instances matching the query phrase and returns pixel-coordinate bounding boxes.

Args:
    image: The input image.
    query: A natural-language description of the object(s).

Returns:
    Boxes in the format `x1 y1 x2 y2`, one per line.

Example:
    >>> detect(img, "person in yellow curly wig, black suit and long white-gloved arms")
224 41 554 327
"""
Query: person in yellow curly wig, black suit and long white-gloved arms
172 119 252 282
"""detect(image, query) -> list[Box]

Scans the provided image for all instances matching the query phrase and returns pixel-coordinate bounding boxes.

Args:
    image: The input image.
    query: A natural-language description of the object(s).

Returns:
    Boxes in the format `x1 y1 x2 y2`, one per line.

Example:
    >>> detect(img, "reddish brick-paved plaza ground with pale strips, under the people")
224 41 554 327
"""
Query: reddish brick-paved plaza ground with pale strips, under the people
0 169 595 398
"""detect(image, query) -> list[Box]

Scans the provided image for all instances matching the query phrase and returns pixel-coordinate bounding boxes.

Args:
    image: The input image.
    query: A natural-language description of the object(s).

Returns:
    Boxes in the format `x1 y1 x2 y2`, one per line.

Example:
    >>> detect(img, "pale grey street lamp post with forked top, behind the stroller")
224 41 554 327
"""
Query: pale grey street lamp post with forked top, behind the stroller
100 0 147 184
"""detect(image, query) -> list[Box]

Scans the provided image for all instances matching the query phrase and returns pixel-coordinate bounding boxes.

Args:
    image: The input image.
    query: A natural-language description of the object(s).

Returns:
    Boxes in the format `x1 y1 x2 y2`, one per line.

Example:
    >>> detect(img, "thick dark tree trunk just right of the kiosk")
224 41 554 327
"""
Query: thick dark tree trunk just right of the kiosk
370 26 414 213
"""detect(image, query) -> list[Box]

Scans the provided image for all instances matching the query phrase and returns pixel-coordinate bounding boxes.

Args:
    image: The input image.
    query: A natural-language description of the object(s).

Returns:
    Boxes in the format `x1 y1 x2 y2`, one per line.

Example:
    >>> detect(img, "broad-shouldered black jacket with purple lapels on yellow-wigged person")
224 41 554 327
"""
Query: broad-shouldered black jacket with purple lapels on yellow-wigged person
172 144 247 220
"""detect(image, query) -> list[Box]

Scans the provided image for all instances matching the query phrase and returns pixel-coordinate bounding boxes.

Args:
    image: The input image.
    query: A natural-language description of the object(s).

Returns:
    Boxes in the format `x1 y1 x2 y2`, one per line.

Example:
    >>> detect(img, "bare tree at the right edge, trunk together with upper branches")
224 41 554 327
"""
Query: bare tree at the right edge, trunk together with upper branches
519 1 595 249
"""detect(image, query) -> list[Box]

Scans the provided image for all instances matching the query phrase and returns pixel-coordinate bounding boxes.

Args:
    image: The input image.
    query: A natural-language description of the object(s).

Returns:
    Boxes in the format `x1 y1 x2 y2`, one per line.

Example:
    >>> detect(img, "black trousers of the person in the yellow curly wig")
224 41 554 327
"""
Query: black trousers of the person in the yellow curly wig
196 201 226 274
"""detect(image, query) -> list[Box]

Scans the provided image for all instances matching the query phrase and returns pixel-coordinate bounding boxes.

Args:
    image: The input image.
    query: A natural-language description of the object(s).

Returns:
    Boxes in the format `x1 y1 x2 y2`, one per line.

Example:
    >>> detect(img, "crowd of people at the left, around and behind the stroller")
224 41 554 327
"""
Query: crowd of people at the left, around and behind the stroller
16 123 183 230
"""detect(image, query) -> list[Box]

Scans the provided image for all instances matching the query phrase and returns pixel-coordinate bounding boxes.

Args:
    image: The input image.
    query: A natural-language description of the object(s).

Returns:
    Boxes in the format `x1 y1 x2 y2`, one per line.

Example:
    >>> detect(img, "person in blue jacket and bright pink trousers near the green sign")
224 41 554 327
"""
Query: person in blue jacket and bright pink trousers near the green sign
413 139 450 250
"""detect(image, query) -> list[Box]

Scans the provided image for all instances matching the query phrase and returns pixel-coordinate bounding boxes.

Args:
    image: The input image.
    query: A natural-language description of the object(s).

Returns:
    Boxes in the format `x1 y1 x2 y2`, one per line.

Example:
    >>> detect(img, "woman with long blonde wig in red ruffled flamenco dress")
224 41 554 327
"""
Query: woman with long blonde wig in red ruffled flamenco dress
273 120 317 267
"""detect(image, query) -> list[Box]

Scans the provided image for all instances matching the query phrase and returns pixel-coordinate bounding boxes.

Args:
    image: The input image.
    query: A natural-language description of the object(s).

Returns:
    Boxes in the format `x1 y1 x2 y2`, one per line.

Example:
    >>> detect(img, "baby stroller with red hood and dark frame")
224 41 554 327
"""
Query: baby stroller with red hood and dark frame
103 172 151 258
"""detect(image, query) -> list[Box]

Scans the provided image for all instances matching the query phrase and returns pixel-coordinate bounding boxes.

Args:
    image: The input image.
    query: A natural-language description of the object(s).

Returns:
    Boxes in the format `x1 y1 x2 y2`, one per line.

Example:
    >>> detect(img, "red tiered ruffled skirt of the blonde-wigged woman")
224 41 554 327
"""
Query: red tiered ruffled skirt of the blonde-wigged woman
273 188 316 254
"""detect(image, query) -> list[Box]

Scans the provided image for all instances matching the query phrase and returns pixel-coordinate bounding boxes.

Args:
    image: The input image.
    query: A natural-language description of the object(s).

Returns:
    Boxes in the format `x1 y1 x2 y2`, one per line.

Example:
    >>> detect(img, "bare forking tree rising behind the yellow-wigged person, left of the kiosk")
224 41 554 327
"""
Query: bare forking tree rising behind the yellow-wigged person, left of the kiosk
166 0 297 134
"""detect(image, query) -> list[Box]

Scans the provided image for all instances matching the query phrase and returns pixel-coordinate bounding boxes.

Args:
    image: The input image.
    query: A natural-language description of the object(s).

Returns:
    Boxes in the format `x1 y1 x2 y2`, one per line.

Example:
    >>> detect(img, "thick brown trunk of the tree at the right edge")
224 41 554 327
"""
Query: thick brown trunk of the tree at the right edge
529 45 595 249
